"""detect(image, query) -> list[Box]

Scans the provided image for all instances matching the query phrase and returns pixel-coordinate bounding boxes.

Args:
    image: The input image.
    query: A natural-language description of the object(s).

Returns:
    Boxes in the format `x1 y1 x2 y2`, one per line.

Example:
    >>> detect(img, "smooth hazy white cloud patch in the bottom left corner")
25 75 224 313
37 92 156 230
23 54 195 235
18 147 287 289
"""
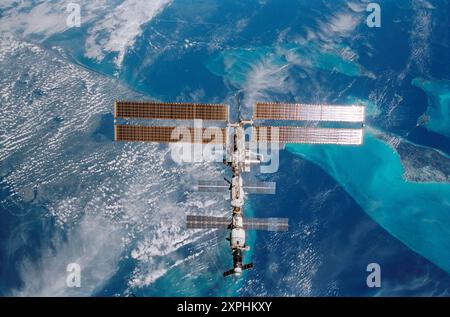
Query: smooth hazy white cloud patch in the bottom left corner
13 216 123 297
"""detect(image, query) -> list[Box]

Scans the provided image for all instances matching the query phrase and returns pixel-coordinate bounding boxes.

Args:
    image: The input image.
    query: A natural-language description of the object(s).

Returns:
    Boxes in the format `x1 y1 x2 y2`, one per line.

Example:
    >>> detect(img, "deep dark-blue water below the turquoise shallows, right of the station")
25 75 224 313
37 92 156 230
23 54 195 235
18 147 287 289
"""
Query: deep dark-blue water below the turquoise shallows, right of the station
243 150 450 296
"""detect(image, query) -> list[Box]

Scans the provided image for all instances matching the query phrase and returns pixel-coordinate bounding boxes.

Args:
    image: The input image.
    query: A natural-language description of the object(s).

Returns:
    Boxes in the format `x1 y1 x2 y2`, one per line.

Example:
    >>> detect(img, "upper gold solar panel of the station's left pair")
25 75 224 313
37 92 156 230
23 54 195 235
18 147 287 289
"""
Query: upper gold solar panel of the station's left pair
115 101 228 121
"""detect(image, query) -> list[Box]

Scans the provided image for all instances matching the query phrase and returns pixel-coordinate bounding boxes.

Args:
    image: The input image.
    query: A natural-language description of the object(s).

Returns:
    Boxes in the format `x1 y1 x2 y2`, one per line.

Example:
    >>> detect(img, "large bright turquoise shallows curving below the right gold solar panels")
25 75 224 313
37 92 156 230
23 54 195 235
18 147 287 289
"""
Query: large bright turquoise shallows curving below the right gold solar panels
286 132 450 272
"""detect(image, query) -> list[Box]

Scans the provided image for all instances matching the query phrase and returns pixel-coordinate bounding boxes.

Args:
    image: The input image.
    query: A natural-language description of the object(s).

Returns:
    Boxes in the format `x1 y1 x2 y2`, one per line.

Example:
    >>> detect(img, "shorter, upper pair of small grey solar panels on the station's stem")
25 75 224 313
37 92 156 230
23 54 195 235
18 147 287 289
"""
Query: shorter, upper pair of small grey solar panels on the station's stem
196 180 276 195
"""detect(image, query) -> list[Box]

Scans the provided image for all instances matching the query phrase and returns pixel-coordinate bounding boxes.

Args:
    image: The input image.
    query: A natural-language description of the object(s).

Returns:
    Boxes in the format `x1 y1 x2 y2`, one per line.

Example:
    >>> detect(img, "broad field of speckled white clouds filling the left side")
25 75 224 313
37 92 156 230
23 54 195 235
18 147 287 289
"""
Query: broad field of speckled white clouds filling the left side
0 37 226 296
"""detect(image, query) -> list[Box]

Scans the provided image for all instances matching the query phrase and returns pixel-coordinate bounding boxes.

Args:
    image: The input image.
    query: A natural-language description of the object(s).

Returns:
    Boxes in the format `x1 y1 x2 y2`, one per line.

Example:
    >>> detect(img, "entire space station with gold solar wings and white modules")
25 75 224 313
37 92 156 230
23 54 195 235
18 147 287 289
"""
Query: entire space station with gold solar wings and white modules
114 98 364 276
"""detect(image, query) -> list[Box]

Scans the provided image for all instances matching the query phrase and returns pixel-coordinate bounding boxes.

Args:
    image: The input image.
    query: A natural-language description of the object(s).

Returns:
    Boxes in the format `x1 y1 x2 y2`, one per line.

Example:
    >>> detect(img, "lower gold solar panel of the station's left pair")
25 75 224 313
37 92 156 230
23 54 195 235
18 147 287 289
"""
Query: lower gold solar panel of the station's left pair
114 125 226 144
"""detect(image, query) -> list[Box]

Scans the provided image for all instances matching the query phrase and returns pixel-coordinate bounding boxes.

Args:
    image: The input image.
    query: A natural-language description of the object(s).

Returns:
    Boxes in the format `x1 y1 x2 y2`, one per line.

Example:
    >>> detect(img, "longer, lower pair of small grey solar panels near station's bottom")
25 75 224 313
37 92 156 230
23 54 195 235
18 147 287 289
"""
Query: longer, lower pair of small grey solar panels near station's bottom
186 215 289 231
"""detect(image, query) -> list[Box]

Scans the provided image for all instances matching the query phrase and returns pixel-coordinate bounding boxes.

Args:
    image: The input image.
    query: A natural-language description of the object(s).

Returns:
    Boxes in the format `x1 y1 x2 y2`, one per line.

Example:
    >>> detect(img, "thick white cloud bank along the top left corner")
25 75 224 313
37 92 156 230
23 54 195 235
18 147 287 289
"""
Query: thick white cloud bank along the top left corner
0 0 172 67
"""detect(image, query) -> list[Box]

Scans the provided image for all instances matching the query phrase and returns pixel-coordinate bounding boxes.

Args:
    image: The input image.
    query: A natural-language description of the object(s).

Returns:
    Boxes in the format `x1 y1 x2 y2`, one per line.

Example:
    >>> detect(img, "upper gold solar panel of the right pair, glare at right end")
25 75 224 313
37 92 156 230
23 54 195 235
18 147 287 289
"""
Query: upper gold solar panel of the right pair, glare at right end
253 102 364 122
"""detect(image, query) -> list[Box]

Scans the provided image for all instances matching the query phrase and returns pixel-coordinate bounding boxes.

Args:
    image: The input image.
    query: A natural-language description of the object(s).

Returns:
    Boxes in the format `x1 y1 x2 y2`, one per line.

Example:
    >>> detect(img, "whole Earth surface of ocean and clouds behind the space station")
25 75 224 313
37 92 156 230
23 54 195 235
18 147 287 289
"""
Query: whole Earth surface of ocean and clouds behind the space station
0 0 450 296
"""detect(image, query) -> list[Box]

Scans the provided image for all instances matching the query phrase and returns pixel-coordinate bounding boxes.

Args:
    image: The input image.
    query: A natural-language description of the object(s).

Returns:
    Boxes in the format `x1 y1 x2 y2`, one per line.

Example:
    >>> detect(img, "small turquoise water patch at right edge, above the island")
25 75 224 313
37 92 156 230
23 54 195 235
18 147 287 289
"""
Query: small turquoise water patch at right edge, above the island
412 78 450 137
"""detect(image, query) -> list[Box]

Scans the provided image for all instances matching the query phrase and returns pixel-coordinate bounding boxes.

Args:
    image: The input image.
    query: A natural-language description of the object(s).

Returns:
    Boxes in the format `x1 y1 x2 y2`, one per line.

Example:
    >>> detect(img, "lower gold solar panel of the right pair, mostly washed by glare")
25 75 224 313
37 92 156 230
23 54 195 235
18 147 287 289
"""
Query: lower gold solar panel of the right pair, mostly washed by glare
252 127 363 145
